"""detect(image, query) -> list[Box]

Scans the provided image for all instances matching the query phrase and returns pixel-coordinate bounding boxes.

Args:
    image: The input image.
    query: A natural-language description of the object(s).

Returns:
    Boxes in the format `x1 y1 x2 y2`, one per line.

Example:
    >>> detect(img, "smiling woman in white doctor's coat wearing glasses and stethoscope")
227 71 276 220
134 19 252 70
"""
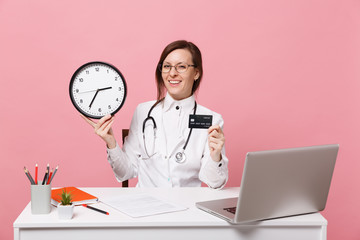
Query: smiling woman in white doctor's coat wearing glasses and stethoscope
82 40 228 188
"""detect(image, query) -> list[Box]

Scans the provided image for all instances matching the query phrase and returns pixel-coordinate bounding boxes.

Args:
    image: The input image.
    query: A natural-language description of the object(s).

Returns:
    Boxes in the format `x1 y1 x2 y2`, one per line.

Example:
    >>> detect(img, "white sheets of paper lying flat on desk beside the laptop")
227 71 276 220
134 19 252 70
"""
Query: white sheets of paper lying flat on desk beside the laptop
100 193 187 218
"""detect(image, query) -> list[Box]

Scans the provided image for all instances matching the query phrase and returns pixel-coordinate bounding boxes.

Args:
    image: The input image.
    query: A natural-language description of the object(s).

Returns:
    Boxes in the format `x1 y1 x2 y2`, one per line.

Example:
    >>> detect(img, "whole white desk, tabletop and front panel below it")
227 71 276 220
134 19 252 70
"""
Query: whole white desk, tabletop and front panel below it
14 188 327 240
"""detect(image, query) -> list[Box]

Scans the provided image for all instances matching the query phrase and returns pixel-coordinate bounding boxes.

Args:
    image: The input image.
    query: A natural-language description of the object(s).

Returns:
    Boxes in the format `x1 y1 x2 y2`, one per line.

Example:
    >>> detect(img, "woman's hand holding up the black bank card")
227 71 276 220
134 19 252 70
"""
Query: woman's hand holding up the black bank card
208 125 225 162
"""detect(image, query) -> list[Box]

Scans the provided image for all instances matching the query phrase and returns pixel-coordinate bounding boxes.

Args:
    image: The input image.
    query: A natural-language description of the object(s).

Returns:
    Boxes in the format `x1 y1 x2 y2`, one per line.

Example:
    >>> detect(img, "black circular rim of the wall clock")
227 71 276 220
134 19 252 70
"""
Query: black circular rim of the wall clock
69 61 127 119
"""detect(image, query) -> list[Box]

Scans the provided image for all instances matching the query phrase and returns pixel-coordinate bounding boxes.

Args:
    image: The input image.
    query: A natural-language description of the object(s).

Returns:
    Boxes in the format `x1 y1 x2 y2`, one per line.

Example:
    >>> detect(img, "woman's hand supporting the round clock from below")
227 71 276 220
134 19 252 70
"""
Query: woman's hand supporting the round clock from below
81 114 116 149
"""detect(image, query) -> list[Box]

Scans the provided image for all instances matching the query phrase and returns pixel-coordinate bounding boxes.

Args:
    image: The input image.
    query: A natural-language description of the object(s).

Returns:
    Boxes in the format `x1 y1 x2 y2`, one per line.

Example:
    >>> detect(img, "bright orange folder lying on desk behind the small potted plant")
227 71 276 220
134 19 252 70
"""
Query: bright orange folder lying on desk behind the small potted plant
51 187 99 206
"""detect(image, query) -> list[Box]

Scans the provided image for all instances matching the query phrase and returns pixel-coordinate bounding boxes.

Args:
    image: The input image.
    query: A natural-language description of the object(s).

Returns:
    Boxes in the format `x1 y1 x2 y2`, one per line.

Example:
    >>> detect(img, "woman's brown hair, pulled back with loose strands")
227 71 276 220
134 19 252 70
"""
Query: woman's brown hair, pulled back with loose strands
155 40 203 101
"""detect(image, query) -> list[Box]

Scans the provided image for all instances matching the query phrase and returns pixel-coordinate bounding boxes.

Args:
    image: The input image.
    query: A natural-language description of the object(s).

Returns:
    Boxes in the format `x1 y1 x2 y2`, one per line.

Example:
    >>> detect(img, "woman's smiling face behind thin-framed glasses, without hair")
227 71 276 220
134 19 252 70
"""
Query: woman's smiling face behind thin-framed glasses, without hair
161 49 199 100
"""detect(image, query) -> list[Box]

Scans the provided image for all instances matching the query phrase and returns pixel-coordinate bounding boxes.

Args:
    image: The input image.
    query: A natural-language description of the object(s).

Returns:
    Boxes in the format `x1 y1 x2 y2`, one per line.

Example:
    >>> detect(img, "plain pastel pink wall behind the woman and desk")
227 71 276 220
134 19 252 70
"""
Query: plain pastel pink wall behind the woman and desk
0 0 360 240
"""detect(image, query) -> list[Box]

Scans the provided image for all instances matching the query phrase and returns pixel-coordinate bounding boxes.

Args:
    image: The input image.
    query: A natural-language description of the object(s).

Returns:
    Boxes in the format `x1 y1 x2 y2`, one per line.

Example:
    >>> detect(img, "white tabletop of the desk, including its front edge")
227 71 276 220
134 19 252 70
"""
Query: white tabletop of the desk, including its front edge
14 188 327 229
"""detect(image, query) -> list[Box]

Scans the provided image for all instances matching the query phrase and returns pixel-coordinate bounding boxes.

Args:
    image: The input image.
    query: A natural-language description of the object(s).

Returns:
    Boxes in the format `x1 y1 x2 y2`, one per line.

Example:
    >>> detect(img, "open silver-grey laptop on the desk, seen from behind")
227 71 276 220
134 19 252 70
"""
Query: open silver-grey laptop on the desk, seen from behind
196 144 339 224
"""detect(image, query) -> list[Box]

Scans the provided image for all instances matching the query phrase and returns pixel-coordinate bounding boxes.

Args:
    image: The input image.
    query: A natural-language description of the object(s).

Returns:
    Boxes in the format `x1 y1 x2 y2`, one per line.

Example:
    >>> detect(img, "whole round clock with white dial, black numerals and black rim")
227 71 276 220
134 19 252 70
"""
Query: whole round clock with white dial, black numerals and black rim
69 62 126 119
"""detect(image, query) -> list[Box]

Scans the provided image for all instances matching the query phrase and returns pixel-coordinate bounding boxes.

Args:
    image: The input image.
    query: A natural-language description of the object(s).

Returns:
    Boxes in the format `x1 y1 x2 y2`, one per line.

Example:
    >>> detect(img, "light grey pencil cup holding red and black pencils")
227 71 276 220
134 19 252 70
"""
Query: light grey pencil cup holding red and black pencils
31 182 51 214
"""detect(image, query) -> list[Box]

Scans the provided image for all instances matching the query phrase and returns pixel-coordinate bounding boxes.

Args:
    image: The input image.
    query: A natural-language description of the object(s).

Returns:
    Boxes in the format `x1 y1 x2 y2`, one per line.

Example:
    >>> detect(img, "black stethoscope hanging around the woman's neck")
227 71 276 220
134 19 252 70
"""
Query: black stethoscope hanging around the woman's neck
142 99 197 163
